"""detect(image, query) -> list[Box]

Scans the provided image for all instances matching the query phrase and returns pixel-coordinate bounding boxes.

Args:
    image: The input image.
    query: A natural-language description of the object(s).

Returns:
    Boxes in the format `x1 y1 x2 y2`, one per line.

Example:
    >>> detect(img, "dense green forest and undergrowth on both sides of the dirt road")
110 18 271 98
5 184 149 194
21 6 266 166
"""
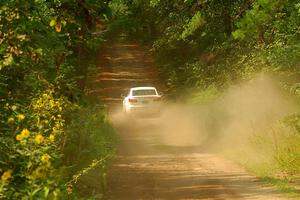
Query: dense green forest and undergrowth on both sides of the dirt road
0 0 300 199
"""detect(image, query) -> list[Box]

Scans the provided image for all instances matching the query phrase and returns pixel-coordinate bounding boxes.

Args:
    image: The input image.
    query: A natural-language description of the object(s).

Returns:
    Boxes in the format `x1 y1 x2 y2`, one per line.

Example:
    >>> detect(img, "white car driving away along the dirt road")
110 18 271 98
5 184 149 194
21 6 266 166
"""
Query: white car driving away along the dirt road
123 87 161 114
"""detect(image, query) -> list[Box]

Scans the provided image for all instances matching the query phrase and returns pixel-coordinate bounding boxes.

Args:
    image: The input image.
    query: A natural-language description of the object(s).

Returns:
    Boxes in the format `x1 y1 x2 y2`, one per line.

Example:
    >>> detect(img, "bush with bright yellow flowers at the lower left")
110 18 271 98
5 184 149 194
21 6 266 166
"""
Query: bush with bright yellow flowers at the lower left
0 91 70 199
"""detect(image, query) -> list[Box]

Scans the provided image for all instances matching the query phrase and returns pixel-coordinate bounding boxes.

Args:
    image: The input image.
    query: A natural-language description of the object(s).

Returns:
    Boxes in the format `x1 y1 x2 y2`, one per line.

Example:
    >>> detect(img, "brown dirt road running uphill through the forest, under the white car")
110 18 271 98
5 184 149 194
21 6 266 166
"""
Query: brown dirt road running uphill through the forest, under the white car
92 38 286 200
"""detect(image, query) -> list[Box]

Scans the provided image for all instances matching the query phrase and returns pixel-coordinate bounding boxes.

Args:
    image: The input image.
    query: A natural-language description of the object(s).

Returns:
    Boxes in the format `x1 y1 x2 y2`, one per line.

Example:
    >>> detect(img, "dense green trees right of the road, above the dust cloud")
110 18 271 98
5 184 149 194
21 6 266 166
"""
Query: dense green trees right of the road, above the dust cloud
112 0 300 92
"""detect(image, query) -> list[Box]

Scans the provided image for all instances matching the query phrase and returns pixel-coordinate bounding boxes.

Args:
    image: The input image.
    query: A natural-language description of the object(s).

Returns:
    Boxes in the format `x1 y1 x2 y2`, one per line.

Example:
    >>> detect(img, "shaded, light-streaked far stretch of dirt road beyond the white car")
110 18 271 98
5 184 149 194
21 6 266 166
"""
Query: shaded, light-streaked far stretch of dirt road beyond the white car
88 40 162 109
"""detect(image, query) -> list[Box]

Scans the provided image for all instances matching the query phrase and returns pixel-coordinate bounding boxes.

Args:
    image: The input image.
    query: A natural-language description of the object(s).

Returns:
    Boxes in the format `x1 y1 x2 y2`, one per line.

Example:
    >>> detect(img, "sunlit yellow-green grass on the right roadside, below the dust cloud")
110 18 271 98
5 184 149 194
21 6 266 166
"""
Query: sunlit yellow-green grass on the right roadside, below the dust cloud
244 114 300 192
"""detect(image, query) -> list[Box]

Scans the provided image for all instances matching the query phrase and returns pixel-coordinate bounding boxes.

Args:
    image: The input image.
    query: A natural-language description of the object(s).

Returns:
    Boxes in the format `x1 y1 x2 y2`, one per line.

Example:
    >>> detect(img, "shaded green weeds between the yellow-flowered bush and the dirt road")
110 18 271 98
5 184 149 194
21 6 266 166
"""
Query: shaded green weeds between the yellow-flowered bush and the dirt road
62 105 117 198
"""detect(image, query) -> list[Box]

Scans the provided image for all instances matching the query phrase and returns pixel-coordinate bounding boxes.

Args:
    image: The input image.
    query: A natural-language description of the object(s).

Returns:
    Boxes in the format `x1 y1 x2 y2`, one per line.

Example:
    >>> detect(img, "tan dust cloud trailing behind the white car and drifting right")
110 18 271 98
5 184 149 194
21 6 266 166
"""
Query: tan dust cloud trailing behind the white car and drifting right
112 76 296 155
